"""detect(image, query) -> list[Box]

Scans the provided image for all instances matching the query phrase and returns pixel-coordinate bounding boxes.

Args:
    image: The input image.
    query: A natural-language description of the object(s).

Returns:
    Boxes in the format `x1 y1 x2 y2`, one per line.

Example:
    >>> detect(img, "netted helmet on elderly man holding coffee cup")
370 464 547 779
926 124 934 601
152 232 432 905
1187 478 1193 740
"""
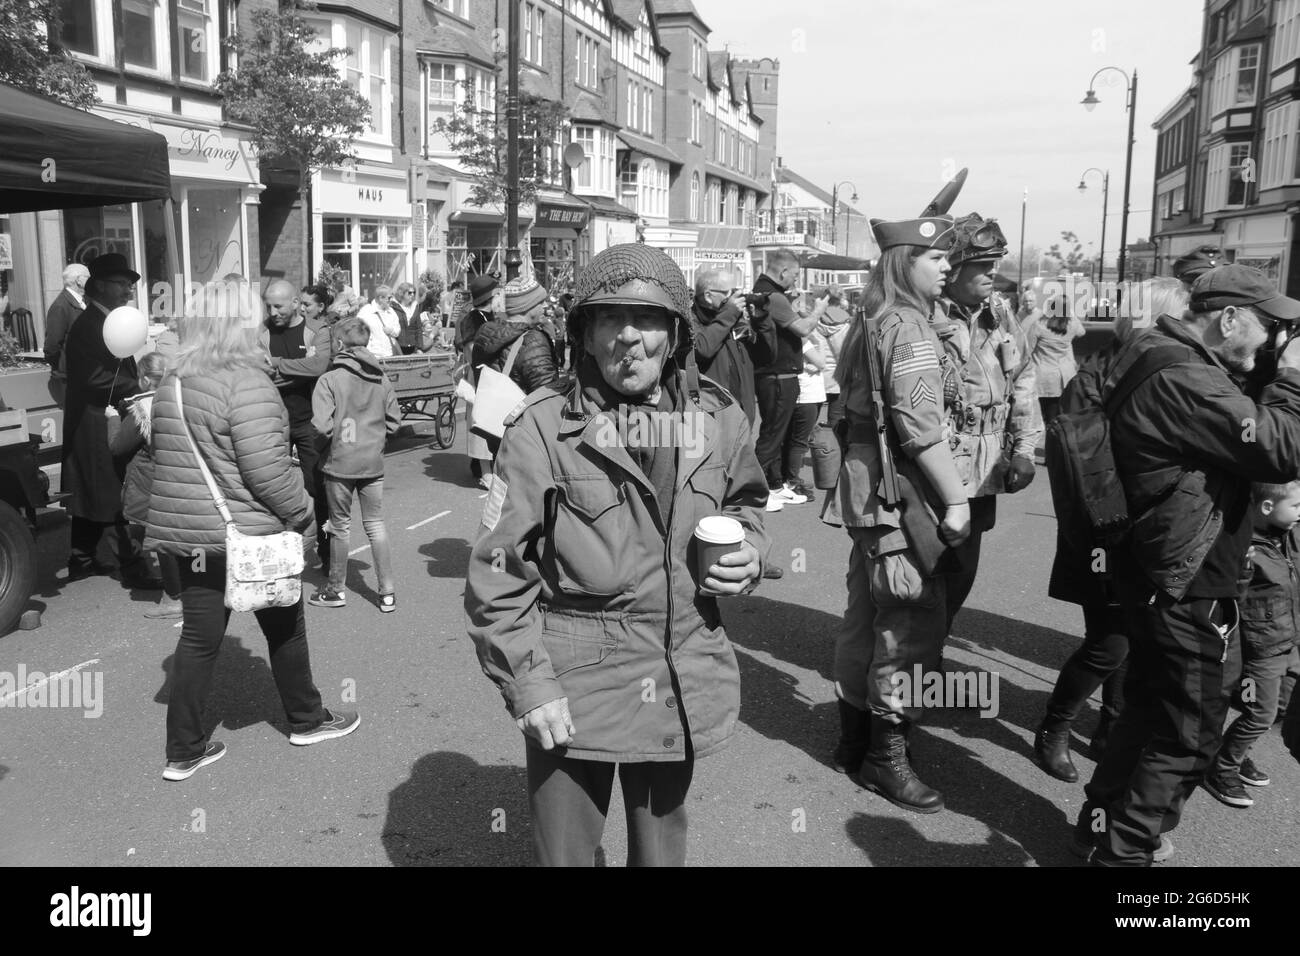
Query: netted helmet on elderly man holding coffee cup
569 242 693 354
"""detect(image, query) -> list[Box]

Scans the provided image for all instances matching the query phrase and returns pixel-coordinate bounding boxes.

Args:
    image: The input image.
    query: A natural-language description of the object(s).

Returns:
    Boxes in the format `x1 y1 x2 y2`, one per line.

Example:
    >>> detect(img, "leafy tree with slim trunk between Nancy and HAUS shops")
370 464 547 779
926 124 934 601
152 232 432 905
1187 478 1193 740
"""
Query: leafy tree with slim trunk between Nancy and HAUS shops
216 0 371 281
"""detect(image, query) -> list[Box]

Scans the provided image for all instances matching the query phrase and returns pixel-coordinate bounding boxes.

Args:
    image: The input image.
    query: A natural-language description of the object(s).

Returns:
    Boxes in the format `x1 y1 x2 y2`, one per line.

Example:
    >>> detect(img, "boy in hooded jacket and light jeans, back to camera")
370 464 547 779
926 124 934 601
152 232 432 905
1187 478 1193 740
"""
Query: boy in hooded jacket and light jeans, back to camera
308 316 402 611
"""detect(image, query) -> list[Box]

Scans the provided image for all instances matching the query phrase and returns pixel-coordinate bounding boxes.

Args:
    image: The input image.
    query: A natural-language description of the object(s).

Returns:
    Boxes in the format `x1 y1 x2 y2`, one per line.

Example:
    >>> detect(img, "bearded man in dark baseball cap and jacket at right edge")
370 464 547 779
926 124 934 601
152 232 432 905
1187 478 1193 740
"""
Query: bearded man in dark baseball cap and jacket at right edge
1071 265 1300 866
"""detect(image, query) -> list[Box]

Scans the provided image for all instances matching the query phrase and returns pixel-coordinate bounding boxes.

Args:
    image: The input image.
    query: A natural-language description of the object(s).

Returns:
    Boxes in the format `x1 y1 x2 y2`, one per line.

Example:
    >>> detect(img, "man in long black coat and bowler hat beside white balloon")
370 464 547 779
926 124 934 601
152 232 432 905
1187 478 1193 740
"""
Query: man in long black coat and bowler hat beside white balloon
62 252 163 588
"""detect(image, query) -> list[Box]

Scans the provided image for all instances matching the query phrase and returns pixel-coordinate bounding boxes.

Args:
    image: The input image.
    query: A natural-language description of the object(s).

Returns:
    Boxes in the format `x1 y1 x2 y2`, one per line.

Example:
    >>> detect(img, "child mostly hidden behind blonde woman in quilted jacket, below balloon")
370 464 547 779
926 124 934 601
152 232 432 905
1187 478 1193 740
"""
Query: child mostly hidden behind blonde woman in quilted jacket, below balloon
105 351 181 619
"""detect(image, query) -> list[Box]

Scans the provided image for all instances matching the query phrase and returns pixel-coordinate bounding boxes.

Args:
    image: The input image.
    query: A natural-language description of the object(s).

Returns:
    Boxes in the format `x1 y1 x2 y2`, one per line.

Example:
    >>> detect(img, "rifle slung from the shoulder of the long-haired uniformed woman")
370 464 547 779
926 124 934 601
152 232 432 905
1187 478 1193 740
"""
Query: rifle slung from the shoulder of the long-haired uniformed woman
866 319 952 578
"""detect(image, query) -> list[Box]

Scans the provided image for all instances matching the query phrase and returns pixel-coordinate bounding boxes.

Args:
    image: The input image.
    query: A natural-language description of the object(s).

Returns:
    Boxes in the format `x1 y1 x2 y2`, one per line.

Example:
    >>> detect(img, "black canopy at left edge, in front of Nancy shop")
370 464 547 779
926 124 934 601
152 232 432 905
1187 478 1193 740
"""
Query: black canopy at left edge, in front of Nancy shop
0 83 172 212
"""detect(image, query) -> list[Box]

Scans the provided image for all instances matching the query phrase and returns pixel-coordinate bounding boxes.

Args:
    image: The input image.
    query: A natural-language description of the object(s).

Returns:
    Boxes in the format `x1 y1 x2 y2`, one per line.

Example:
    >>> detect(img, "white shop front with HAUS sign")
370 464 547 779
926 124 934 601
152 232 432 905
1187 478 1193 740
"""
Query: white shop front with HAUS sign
312 165 415 299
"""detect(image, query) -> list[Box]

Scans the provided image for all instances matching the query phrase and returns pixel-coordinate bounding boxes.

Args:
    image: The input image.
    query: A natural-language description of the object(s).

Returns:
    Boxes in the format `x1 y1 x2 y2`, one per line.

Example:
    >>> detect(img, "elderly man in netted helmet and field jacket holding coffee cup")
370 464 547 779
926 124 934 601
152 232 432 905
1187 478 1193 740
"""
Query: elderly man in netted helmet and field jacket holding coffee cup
465 243 768 866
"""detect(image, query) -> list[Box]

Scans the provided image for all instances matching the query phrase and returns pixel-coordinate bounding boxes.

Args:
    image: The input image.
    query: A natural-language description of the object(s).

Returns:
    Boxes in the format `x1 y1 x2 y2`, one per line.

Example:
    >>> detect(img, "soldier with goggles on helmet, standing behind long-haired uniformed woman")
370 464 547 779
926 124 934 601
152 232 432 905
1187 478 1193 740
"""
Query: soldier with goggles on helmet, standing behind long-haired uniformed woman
933 212 1043 632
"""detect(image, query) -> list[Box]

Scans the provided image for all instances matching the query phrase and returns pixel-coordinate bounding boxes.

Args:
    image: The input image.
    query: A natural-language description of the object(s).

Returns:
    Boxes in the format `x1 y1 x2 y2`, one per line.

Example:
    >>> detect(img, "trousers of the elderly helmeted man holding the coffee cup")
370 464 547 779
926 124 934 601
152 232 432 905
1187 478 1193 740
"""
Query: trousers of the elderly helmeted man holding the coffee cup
527 744 694 866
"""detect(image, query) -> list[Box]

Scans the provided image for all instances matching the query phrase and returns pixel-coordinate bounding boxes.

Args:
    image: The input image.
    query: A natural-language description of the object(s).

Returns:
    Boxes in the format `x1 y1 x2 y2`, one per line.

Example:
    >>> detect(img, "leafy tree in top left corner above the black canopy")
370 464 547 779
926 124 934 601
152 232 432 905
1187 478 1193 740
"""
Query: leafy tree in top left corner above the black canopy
0 0 99 109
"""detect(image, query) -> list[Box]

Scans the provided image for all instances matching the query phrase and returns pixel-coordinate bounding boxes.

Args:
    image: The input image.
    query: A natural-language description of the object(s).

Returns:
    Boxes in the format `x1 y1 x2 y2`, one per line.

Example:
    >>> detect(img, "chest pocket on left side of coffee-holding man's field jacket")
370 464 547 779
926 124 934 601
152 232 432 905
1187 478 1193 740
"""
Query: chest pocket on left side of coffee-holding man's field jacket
551 475 634 597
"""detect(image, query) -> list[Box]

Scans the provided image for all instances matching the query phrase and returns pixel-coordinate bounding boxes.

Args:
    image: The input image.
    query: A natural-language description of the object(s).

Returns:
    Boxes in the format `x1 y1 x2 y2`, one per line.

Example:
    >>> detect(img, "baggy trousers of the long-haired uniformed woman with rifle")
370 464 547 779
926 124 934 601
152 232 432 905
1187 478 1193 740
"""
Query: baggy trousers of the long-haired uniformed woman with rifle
833 528 948 723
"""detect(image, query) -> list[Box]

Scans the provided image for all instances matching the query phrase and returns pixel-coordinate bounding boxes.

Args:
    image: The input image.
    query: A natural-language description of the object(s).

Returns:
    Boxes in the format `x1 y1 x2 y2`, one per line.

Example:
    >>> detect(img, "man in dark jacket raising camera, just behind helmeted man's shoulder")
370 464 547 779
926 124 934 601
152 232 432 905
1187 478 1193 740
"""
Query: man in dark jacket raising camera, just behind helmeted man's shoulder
690 269 776 425
